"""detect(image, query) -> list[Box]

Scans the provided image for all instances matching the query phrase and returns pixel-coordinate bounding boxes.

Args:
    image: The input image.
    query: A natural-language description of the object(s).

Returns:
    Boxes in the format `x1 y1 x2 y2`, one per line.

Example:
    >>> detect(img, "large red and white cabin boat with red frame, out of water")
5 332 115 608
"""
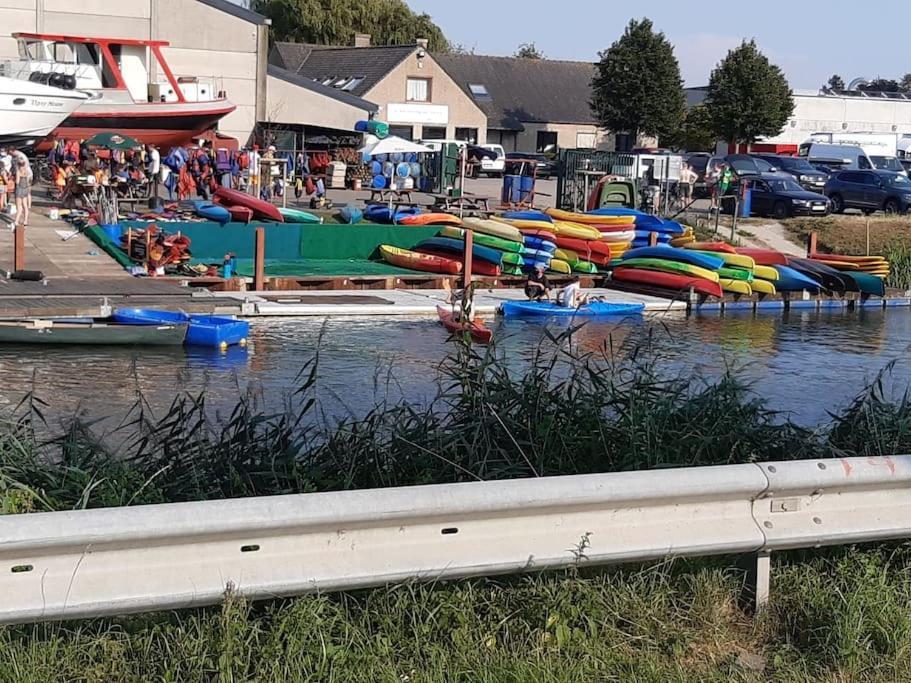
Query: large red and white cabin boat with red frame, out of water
0 33 236 148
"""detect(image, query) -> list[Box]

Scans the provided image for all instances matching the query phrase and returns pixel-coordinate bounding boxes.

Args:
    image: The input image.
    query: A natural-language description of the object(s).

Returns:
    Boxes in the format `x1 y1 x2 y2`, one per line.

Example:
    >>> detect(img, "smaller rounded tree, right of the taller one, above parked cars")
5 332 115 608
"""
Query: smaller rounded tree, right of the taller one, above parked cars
705 40 794 144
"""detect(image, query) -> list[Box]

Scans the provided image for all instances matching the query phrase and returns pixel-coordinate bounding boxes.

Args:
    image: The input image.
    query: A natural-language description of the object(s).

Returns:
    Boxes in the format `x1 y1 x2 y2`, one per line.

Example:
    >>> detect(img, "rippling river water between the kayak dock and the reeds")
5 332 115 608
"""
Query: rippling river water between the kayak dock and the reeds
0 309 911 424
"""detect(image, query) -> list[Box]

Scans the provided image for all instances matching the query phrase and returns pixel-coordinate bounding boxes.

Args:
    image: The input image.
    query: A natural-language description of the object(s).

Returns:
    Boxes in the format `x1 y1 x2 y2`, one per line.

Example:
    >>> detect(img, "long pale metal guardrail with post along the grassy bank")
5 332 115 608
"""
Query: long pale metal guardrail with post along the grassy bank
0 456 911 623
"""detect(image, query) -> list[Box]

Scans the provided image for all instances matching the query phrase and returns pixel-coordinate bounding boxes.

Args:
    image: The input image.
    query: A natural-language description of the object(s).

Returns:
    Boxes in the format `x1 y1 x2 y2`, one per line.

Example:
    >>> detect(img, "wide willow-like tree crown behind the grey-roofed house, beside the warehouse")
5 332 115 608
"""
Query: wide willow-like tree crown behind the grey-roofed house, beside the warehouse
251 0 450 52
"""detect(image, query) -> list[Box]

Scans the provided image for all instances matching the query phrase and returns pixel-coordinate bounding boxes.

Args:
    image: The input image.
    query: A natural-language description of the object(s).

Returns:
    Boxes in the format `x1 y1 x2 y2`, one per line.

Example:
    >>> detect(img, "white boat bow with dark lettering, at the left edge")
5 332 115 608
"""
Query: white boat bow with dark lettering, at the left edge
0 76 88 146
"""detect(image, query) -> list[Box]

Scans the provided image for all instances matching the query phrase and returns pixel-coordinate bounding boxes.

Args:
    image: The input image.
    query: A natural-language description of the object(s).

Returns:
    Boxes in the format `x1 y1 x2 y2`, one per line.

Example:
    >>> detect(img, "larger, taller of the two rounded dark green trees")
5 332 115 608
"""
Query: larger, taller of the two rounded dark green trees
590 19 686 144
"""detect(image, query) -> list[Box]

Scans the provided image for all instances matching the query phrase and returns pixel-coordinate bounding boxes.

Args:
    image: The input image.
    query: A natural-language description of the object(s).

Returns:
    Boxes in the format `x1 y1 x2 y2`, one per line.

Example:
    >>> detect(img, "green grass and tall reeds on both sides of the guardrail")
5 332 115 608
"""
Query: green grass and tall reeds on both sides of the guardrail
0 331 911 683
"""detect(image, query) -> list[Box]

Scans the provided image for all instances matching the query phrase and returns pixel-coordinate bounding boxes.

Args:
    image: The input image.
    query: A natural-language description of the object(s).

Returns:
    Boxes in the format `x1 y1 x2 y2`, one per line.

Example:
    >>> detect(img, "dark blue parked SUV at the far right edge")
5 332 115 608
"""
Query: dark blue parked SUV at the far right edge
825 171 911 214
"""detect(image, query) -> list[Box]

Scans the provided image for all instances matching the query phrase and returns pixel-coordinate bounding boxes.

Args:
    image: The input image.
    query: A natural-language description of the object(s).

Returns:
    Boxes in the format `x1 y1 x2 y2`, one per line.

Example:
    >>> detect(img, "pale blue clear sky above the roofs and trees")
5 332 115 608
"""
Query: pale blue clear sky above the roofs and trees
406 0 911 90
